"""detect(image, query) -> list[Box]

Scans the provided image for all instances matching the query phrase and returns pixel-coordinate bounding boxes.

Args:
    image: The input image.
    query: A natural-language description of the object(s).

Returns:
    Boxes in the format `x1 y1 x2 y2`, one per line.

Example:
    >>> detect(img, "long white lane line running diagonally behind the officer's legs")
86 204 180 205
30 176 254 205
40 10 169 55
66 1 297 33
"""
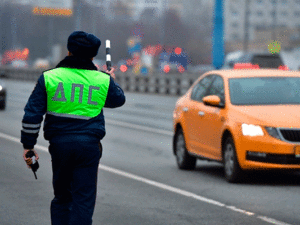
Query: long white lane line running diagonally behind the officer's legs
0 132 291 225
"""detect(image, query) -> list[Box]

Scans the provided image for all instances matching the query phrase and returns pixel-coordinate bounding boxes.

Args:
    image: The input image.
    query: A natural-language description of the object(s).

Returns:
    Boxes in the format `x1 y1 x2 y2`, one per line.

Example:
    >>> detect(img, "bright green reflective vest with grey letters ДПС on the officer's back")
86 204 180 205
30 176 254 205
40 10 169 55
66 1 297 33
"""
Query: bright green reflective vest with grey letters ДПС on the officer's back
44 67 110 120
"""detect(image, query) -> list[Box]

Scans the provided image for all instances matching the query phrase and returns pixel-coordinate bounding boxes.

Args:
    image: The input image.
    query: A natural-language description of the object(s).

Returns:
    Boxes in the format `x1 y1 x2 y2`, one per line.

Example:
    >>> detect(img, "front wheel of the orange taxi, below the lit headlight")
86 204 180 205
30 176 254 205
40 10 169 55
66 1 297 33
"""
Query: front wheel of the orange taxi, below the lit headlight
223 137 242 183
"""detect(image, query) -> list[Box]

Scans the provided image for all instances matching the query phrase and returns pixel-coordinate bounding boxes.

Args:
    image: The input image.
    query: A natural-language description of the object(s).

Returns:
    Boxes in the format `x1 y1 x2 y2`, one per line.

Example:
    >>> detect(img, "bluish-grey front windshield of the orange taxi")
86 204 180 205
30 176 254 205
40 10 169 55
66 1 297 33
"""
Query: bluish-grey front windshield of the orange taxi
229 77 300 105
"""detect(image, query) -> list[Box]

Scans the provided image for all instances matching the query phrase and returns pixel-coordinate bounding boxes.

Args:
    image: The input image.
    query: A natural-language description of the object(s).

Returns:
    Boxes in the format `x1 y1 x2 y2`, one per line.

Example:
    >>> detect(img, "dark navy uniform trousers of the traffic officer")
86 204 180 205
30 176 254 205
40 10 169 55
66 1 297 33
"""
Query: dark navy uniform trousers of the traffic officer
49 135 102 225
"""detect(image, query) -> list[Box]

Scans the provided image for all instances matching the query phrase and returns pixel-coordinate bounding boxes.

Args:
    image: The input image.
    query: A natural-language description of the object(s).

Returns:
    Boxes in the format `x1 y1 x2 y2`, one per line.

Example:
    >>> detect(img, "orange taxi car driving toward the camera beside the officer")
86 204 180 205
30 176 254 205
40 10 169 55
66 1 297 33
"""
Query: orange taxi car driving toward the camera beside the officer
173 63 300 182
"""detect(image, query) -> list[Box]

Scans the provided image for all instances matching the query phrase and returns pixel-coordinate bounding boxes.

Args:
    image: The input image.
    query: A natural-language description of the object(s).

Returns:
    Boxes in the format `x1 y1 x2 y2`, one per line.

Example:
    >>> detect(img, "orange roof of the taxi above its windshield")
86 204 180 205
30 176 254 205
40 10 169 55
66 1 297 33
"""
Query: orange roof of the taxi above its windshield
204 69 300 79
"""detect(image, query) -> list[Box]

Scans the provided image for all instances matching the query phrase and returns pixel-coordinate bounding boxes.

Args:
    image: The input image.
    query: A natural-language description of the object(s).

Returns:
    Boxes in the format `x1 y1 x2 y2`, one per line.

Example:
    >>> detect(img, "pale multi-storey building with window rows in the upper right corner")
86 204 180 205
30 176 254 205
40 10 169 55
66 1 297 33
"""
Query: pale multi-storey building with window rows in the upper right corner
224 0 300 49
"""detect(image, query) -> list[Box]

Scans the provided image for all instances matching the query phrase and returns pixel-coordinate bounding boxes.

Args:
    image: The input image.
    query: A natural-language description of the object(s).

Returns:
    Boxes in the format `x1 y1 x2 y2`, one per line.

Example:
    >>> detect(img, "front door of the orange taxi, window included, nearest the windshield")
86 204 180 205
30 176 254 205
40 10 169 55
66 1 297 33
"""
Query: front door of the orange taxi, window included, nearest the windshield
199 75 226 160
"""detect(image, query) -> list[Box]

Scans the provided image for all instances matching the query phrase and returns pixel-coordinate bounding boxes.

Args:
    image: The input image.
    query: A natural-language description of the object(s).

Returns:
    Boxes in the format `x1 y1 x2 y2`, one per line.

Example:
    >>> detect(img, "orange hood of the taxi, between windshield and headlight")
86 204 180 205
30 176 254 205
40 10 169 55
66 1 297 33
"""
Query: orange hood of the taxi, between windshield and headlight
228 105 300 128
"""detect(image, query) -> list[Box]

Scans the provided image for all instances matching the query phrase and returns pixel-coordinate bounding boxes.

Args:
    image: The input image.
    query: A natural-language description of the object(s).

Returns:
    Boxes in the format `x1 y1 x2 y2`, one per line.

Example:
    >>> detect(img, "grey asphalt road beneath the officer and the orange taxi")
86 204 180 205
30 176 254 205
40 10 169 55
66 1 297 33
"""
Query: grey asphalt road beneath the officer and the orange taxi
0 81 300 225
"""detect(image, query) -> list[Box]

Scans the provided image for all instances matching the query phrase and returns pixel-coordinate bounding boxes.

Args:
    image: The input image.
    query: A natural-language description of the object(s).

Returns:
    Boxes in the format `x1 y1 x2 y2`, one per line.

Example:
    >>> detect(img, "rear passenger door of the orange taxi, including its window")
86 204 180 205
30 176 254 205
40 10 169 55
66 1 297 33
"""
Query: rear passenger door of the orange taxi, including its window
183 75 213 155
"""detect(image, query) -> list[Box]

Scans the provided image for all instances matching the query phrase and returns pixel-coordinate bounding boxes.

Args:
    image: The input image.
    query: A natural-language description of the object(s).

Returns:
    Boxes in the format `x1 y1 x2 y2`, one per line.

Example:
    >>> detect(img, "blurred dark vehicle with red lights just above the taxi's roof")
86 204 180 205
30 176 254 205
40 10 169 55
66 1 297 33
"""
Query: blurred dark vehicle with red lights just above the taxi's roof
222 51 284 69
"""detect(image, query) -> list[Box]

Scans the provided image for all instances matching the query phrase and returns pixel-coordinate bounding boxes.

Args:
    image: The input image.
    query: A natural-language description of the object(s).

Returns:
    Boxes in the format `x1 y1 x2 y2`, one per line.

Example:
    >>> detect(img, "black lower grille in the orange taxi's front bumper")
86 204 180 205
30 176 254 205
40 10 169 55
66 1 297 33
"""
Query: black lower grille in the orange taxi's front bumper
246 154 300 165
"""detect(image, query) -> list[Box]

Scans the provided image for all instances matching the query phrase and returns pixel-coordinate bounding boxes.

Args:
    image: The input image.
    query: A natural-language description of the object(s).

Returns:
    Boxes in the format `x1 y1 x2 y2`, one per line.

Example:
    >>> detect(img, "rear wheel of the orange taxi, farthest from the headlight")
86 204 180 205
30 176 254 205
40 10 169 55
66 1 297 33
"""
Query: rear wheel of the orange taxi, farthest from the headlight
175 129 197 170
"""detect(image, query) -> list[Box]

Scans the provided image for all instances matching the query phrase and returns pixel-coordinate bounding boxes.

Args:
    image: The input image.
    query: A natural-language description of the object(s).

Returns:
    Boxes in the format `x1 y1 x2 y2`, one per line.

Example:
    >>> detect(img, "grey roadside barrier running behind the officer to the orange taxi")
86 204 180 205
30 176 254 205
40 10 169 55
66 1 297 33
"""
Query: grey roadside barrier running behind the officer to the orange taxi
0 67 201 96
